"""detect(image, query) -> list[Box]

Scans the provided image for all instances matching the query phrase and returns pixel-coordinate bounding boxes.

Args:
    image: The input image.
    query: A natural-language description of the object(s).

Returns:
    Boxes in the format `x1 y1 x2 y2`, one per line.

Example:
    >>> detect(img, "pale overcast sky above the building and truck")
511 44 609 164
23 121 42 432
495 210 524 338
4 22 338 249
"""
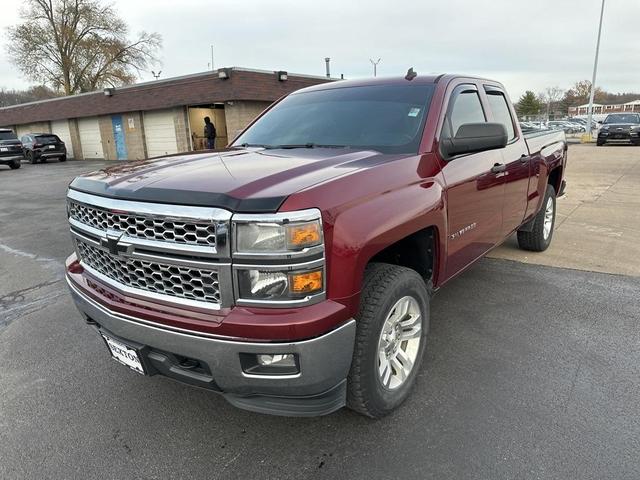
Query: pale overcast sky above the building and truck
0 0 640 100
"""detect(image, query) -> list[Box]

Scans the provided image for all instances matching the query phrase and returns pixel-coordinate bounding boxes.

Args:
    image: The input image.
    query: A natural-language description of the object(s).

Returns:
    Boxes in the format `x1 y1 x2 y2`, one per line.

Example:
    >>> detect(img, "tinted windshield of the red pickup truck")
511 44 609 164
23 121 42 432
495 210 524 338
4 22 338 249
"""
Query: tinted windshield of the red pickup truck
234 84 434 153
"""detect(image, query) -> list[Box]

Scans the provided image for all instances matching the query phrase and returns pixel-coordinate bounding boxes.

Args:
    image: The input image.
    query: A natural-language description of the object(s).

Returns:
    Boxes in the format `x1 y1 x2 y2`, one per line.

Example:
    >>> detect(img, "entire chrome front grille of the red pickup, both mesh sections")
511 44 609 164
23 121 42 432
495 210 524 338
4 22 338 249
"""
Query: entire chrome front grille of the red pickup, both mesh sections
67 190 233 310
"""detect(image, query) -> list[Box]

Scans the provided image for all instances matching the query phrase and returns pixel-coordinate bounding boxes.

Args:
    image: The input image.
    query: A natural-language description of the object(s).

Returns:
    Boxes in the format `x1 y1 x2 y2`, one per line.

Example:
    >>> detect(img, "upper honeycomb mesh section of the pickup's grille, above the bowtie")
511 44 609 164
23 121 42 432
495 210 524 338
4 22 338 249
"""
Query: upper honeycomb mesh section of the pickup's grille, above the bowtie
69 201 216 247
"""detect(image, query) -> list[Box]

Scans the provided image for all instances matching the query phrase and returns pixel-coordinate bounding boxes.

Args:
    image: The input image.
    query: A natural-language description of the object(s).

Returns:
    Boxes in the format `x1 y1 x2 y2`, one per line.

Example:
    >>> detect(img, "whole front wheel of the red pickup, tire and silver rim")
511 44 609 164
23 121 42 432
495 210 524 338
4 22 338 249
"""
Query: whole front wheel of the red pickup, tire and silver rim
347 263 429 418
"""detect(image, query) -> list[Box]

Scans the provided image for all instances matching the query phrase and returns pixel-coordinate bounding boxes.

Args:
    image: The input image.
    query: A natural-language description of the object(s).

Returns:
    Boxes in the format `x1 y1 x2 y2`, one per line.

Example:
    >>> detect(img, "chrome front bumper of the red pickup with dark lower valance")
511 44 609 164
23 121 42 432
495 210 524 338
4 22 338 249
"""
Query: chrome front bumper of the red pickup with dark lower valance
68 281 356 416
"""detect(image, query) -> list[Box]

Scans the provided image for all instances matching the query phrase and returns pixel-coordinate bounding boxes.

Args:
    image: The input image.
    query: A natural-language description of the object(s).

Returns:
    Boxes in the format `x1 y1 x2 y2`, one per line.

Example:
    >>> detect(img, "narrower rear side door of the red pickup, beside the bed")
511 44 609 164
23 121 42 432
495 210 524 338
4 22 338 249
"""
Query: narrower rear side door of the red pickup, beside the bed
484 85 531 238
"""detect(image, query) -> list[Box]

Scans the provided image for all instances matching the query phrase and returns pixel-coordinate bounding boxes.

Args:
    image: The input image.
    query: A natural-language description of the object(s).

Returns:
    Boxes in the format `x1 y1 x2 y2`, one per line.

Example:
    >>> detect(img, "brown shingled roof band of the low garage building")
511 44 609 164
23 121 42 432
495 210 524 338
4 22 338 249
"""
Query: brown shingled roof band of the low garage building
0 67 335 125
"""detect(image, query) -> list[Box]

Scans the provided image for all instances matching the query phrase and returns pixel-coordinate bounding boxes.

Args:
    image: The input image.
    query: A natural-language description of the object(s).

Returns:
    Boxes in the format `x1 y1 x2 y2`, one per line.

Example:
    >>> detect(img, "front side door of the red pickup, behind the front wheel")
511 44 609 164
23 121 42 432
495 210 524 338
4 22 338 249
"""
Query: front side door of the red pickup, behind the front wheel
439 84 504 279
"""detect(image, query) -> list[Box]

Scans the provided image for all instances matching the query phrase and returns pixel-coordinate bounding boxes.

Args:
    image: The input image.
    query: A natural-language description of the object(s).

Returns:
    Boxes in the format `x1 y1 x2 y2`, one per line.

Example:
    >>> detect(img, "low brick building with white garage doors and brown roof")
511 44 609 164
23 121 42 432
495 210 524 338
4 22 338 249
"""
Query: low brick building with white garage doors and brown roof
0 67 330 160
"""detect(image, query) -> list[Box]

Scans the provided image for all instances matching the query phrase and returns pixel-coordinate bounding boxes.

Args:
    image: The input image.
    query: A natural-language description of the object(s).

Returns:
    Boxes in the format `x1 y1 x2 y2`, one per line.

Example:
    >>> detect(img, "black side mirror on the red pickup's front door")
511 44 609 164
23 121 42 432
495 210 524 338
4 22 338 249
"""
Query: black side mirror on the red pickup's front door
442 122 508 157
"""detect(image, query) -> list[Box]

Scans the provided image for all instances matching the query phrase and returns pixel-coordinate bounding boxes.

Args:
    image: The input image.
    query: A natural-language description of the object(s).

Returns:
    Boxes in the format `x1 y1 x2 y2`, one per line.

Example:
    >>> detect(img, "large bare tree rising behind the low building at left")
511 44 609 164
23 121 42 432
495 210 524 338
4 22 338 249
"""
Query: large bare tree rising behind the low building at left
7 0 162 95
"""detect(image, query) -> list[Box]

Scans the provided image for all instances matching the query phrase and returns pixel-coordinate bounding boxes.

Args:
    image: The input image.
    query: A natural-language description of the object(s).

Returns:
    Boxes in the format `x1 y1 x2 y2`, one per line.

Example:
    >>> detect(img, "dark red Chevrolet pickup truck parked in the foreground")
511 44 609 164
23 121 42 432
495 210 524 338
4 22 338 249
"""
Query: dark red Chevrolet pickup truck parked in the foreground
67 75 567 417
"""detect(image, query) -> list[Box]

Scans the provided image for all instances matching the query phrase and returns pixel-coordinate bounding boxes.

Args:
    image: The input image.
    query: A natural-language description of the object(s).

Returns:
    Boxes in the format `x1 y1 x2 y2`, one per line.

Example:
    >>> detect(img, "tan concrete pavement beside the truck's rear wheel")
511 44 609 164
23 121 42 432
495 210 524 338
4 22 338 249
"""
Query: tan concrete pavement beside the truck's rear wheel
489 144 640 276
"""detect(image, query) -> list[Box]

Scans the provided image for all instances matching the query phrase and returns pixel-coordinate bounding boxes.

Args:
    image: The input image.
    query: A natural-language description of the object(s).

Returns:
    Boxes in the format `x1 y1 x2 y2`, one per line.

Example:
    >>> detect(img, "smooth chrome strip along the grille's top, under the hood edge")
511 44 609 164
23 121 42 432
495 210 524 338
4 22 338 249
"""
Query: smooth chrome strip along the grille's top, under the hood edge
67 189 232 222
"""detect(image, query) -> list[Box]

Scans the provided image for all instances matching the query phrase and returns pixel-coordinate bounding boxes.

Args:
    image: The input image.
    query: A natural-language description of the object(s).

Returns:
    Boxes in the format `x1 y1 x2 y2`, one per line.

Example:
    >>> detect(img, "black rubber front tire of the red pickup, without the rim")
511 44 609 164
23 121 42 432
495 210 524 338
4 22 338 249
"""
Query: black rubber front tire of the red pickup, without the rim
347 263 429 418
